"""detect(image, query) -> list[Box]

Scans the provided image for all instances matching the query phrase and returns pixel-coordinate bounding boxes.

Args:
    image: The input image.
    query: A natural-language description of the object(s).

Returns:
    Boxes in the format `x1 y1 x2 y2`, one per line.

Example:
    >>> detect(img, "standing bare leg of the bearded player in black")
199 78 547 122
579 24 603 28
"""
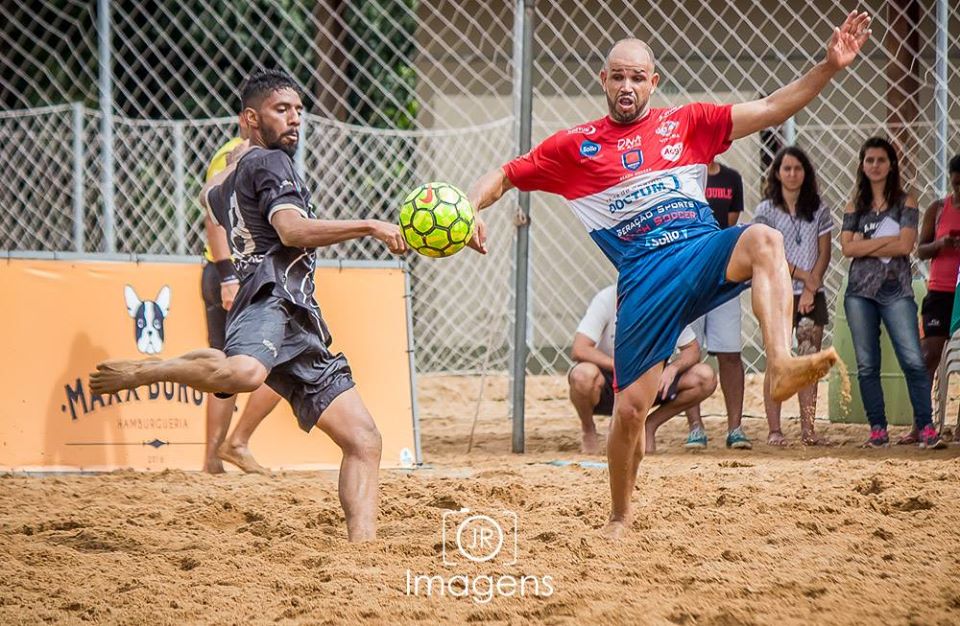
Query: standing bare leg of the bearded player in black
317 387 382 541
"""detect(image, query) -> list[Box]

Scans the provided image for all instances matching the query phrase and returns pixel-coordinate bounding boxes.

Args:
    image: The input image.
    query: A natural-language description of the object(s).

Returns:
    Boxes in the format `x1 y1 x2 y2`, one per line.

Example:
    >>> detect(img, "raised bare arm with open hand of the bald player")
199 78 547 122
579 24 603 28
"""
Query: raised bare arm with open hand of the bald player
730 11 870 140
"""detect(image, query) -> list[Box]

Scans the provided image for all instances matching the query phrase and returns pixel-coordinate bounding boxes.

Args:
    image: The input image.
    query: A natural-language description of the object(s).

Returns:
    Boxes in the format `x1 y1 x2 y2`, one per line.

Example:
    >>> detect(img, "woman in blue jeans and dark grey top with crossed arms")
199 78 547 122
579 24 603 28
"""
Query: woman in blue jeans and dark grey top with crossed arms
840 137 944 448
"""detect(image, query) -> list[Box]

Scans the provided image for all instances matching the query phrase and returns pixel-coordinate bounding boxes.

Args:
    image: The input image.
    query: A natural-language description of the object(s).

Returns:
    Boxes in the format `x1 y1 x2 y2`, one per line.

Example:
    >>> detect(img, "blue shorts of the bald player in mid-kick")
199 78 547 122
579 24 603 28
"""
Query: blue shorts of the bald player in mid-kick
613 226 750 391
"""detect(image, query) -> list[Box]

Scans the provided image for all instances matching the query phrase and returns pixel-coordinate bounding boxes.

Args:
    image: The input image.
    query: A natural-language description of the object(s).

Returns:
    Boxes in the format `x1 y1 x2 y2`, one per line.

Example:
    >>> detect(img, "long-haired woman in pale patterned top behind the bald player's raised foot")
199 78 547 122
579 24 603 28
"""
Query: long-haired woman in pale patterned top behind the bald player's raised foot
753 146 833 446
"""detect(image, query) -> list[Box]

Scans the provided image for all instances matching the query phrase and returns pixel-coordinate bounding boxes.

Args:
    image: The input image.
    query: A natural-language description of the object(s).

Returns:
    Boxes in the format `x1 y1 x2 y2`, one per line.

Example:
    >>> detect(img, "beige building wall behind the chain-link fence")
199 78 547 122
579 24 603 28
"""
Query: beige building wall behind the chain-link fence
408 0 960 363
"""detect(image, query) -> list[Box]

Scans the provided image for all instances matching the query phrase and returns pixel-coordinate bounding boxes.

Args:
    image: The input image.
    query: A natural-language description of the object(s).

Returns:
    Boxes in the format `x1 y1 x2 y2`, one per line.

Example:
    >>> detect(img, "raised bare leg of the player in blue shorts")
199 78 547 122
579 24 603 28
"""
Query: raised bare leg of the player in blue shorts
727 224 839 402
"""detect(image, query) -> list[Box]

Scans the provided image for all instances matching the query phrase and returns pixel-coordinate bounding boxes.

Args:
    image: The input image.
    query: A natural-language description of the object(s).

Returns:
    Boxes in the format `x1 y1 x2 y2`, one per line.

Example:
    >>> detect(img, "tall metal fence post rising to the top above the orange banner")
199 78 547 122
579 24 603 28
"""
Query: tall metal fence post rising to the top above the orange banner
97 0 116 252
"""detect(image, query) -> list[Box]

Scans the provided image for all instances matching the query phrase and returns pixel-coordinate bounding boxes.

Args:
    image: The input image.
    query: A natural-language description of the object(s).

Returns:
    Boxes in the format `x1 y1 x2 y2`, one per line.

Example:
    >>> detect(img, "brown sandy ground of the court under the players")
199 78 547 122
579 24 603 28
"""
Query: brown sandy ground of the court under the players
0 377 960 624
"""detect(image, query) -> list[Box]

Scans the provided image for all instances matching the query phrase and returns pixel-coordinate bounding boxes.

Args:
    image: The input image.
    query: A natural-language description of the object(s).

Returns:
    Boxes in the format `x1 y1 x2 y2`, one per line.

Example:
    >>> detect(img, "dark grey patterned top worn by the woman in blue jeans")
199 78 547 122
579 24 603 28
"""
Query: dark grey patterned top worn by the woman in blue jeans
842 202 920 304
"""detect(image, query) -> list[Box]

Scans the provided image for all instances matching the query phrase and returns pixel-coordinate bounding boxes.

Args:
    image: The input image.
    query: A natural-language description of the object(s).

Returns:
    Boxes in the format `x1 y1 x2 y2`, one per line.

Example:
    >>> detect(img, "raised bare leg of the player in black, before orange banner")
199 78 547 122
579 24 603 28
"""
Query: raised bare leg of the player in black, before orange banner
90 348 269 394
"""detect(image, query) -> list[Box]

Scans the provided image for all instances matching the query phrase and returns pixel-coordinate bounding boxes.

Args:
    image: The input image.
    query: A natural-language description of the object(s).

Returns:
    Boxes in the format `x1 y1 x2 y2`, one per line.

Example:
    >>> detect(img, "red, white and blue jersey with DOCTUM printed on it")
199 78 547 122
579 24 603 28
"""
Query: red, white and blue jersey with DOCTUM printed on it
503 103 733 268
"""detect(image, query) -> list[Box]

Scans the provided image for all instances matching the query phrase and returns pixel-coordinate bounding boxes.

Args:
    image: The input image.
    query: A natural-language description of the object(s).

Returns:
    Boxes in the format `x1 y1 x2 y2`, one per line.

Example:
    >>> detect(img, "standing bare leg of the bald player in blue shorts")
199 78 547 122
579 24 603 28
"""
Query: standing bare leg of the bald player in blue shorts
603 363 663 540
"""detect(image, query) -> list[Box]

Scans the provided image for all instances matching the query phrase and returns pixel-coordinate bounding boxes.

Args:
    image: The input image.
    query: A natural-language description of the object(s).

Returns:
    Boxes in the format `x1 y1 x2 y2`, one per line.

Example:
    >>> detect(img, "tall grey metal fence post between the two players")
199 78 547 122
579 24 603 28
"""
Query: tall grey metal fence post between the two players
511 0 536 453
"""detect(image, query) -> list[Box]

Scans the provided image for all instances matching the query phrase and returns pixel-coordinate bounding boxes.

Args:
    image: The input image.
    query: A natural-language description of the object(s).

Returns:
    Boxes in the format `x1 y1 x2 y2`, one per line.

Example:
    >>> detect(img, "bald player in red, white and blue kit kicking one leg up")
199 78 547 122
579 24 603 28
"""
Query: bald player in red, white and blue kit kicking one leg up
468 11 870 540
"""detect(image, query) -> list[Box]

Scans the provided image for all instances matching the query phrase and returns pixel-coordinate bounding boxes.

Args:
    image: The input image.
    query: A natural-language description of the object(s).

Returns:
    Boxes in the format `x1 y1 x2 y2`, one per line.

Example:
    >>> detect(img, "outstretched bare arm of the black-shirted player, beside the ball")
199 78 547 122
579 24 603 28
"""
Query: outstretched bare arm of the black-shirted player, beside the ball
270 207 407 254
